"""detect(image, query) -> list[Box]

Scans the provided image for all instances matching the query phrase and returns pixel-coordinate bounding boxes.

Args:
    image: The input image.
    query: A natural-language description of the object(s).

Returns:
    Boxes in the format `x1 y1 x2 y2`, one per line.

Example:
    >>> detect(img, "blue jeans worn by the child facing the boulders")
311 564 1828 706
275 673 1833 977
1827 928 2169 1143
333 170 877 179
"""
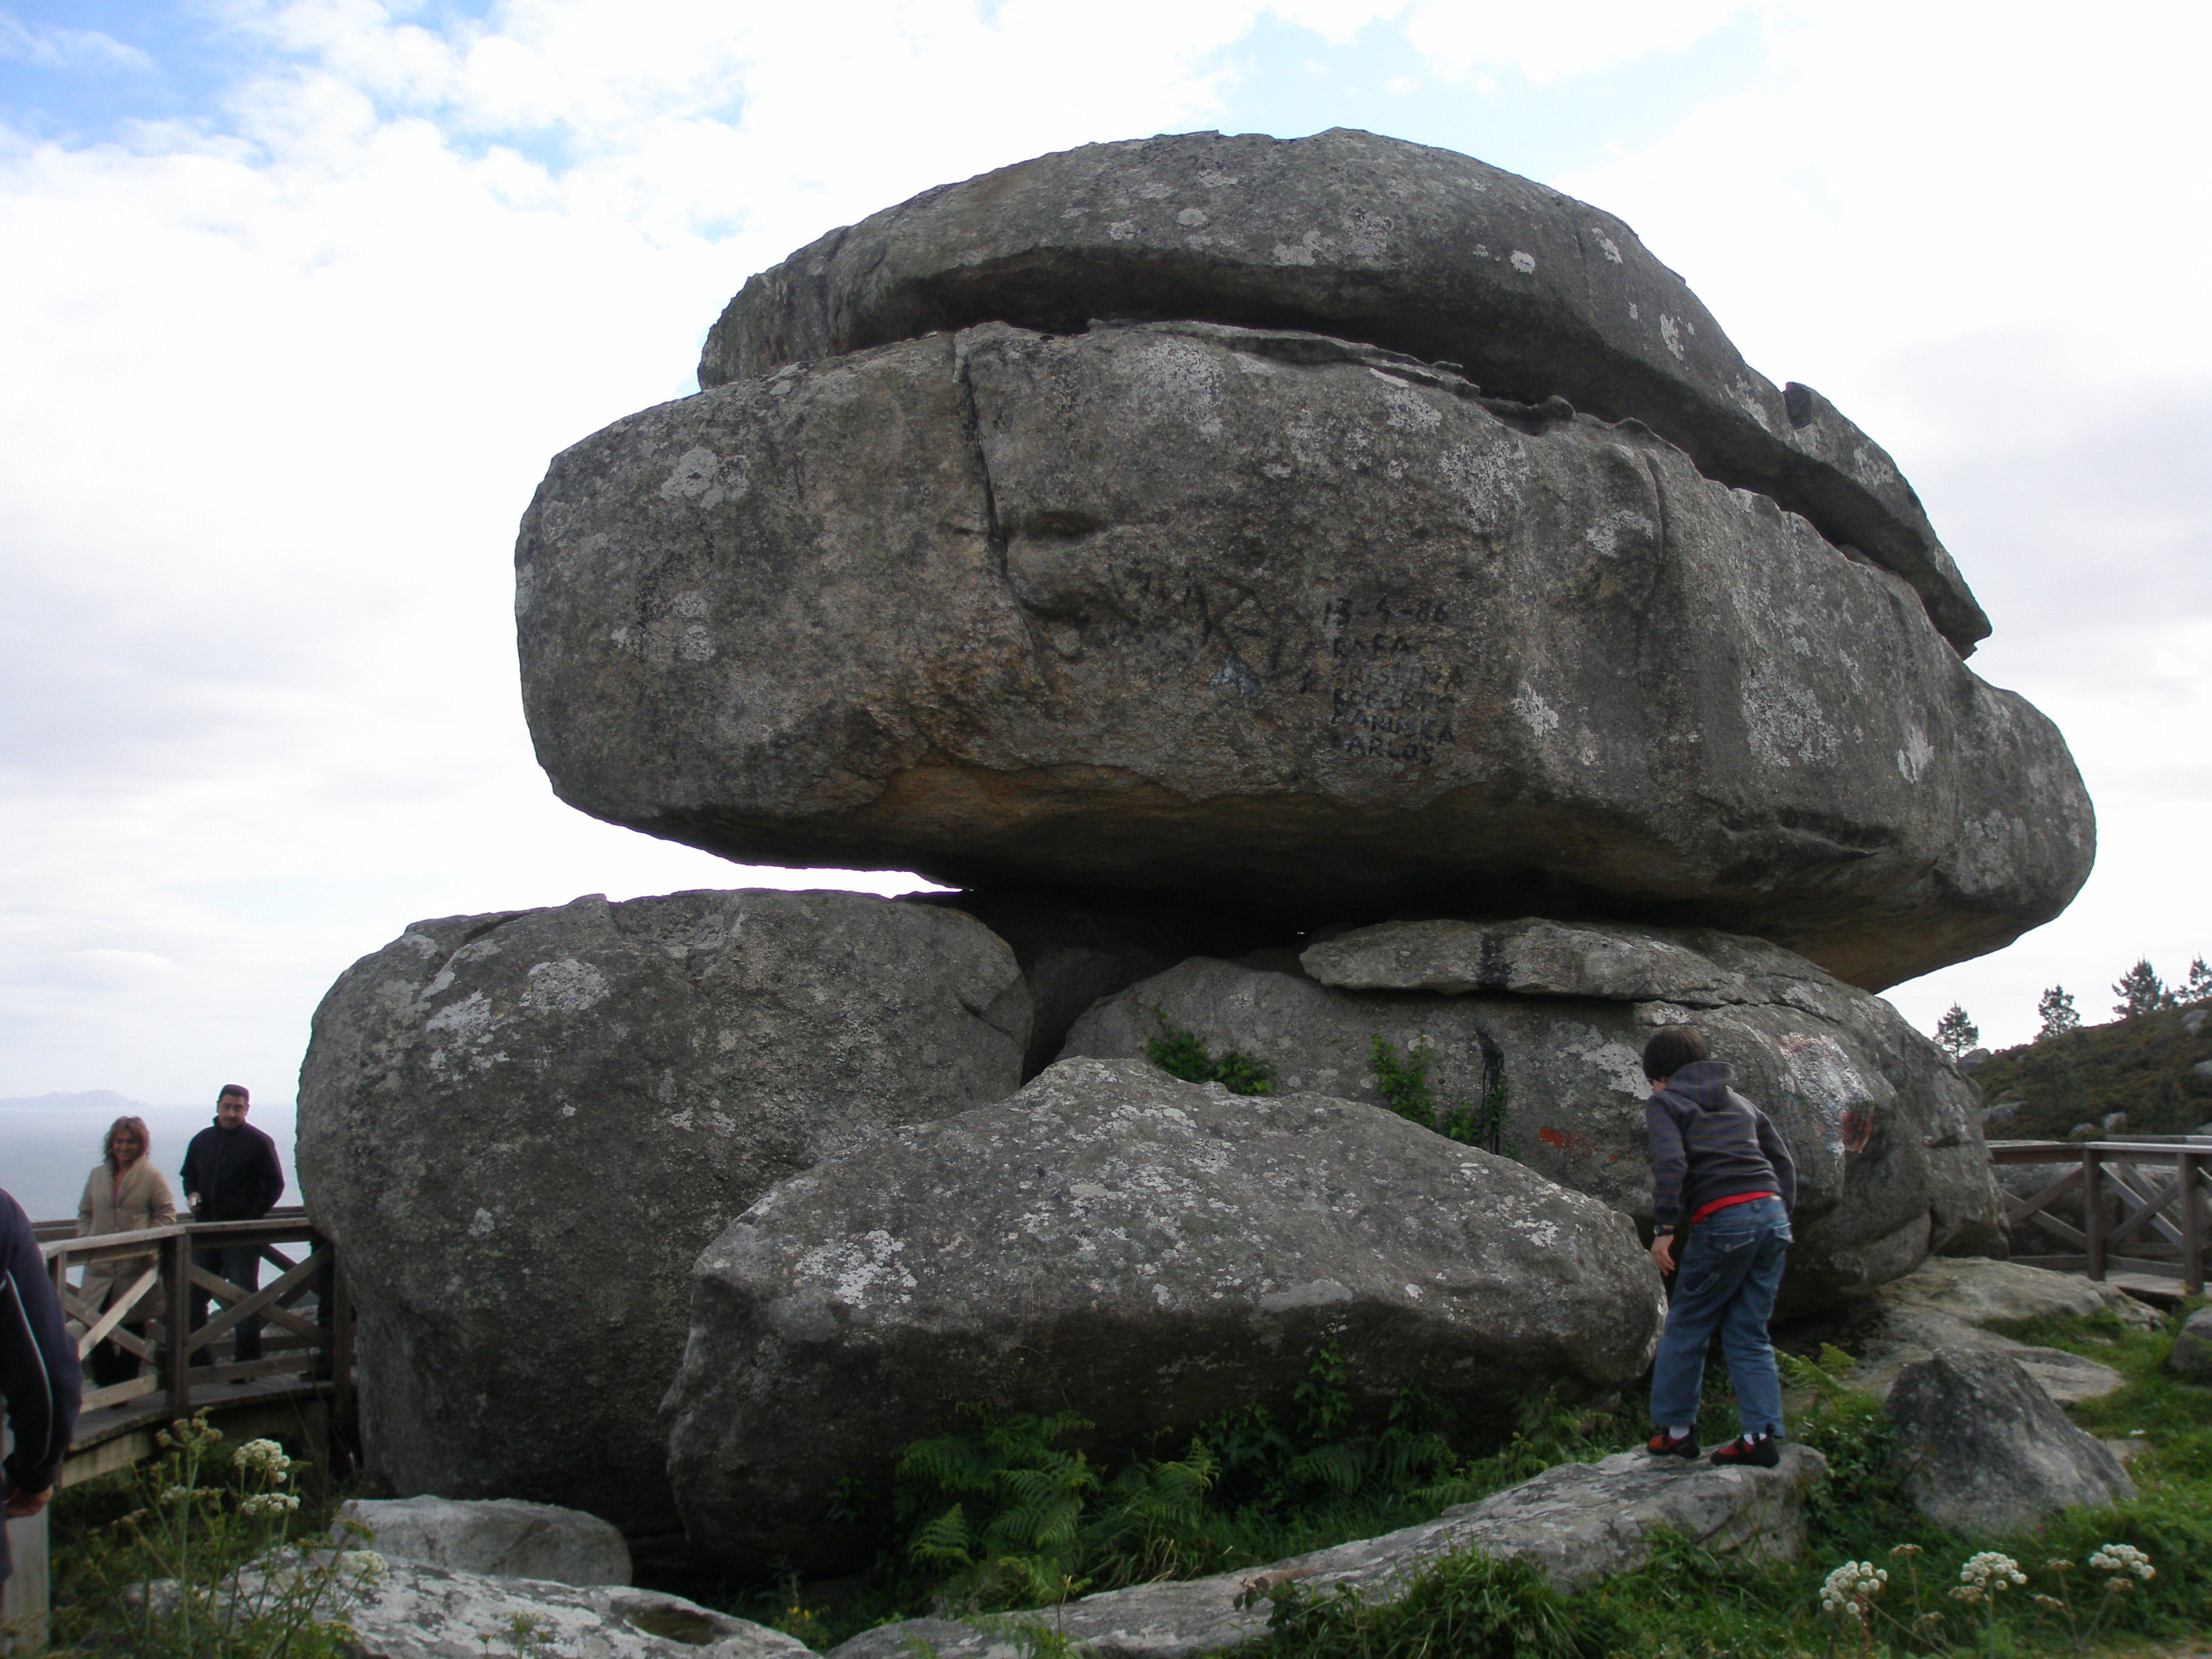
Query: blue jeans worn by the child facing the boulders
1652 1199 1789 1433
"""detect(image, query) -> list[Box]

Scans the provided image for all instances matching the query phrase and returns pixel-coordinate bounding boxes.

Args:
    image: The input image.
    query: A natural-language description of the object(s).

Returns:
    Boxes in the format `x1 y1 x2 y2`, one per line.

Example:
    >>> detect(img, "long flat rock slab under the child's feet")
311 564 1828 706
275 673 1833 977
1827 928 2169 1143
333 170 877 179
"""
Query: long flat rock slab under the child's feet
832 1444 1827 1659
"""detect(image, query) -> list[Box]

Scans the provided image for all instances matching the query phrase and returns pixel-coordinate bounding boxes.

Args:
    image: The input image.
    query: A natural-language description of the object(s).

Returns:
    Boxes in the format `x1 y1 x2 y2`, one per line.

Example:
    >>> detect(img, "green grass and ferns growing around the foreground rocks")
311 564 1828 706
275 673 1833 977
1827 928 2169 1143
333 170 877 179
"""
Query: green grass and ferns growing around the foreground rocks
730 1316 2212 1659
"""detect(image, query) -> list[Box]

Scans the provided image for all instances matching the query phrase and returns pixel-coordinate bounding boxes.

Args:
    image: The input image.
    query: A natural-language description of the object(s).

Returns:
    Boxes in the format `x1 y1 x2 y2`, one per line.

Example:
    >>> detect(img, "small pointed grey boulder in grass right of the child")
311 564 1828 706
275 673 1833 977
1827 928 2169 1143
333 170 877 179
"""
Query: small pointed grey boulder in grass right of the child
1887 1349 2134 1537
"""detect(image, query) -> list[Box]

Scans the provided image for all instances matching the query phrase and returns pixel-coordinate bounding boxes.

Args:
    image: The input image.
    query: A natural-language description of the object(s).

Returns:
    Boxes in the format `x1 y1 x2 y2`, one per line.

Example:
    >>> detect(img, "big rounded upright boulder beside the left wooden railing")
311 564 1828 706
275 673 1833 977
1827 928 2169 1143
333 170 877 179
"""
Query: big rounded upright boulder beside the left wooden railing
298 891 1028 1530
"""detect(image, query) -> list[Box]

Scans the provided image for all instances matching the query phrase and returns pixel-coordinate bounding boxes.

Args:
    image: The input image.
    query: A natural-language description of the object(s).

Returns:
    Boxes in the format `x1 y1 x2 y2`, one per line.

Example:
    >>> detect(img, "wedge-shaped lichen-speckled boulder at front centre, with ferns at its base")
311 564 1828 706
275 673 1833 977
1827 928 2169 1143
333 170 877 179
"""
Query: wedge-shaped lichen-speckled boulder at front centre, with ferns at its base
666 1059 1659 1568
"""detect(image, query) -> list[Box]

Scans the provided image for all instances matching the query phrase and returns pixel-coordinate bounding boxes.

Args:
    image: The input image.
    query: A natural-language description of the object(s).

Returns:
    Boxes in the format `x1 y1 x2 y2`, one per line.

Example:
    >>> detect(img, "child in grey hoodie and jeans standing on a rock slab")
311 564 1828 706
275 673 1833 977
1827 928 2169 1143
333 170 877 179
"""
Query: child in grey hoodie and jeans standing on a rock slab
1643 1027 1796 1469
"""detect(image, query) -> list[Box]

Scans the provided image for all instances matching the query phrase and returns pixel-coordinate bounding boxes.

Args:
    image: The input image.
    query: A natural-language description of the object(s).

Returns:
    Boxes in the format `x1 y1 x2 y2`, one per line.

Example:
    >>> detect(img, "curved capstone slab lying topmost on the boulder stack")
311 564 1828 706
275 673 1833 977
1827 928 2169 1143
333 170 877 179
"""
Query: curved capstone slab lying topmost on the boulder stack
699 129 1989 652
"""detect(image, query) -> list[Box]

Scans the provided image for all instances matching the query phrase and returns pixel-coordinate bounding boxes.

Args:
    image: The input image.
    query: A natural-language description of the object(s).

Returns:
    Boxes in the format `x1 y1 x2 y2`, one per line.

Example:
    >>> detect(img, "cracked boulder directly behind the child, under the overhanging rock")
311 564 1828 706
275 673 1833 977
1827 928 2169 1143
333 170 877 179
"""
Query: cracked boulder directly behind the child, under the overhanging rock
1064 918 1997 1314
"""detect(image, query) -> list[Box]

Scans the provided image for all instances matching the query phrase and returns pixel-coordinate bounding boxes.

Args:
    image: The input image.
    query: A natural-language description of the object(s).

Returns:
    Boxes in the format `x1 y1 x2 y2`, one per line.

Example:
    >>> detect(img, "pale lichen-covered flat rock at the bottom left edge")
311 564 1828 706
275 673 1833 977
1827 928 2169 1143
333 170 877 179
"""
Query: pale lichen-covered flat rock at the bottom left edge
347 1560 809 1659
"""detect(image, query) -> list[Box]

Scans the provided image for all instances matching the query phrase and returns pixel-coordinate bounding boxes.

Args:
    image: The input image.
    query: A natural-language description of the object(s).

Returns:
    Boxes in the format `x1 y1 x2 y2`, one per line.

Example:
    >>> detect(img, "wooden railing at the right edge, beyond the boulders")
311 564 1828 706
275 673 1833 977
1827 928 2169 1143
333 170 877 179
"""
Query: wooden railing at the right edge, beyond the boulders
1989 1134 2212 1296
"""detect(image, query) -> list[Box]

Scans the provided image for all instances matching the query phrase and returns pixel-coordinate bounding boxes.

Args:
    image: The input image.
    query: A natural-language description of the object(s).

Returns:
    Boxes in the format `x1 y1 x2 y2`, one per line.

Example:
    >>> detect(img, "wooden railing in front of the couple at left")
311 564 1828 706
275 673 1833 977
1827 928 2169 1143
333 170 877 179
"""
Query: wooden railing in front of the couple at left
38 1210 354 1418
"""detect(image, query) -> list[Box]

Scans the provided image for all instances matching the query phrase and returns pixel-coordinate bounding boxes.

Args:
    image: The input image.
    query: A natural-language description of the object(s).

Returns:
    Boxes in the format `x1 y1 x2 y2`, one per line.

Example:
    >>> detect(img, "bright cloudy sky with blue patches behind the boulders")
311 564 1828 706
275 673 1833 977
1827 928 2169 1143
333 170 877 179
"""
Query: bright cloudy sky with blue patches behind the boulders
0 0 2212 1119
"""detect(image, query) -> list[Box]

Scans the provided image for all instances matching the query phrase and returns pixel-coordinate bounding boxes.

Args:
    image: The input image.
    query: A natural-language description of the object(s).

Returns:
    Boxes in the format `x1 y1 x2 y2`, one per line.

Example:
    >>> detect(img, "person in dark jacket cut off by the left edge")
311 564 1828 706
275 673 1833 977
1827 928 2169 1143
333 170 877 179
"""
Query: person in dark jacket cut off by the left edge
0 1192 84 1580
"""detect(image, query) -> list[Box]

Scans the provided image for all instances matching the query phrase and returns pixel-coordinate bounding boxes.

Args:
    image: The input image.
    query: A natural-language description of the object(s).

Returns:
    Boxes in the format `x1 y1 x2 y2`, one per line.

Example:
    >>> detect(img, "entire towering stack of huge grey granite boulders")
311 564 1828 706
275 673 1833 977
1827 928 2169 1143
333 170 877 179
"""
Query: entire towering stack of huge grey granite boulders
301 130 2093 1564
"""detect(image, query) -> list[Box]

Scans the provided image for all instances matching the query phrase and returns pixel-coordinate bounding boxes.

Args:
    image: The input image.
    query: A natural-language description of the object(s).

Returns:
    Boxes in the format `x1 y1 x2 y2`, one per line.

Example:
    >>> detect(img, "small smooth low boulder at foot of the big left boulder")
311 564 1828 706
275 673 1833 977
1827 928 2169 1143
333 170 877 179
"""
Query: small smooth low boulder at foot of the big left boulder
334 1498 631 1584
